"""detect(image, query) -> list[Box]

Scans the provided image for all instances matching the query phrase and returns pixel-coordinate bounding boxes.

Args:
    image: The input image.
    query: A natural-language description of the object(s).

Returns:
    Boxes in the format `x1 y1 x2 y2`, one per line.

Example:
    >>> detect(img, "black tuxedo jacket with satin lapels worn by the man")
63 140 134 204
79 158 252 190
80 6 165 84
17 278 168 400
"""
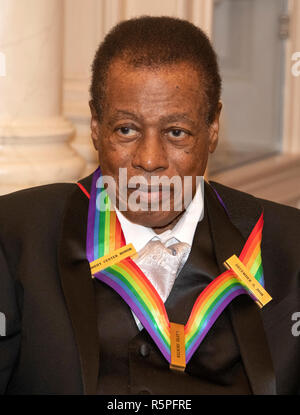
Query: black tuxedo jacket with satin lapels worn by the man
0 177 300 394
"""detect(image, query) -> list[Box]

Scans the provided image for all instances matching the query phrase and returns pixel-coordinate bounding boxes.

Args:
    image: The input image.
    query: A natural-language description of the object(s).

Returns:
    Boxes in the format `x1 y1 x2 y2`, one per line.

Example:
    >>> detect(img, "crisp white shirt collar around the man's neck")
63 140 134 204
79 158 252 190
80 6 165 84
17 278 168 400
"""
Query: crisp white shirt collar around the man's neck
115 180 204 252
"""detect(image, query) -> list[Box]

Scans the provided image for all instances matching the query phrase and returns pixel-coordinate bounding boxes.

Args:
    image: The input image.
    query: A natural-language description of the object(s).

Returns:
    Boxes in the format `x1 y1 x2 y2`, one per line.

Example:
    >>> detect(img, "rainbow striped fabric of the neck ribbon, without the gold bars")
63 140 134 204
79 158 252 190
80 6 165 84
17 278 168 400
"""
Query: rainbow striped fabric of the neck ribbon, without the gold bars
84 168 264 364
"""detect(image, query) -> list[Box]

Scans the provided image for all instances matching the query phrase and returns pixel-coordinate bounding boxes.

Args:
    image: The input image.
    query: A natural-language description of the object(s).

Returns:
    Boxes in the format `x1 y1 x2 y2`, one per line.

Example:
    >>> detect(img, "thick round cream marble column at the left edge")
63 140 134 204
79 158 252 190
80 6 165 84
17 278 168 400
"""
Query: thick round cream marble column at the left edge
0 0 84 194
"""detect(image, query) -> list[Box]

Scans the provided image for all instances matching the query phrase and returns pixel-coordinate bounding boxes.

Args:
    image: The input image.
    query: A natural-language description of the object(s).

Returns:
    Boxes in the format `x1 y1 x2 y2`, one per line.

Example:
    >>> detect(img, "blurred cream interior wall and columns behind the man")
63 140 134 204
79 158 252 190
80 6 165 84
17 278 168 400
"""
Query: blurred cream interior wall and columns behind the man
0 0 300 208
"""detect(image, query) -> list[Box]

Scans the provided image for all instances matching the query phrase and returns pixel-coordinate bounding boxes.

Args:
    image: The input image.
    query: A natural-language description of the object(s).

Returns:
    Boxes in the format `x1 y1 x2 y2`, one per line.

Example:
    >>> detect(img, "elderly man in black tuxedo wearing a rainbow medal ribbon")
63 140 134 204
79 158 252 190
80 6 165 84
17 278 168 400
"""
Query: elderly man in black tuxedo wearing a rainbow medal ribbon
0 17 300 394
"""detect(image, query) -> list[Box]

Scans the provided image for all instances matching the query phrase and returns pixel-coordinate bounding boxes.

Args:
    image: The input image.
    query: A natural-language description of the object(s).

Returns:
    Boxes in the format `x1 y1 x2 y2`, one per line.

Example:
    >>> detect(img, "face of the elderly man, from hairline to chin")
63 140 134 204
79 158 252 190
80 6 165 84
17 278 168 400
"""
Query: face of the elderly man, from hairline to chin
91 60 221 233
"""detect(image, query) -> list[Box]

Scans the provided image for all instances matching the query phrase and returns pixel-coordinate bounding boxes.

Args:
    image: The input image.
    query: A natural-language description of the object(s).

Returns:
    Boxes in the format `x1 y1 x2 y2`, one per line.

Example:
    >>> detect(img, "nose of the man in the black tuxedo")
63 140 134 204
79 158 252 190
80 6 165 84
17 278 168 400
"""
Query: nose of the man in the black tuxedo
132 131 169 172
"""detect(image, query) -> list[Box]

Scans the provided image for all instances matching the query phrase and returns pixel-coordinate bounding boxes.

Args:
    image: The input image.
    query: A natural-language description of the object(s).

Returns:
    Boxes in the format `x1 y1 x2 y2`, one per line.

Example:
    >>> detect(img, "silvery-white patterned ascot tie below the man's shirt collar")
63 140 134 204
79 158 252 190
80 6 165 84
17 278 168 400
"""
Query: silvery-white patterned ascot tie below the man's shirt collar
133 238 190 329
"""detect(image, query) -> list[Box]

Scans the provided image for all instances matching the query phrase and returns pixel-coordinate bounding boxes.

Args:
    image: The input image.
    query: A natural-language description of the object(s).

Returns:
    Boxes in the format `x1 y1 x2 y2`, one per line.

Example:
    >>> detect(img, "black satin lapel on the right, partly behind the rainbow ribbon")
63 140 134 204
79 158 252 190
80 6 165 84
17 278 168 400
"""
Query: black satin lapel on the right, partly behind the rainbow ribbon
205 183 276 394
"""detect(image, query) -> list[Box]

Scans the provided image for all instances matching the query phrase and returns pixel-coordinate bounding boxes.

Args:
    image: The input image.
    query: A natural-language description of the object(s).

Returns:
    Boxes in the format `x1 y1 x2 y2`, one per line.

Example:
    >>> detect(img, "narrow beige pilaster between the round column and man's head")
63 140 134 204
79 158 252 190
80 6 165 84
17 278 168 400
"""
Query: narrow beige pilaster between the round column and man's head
63 0 123 176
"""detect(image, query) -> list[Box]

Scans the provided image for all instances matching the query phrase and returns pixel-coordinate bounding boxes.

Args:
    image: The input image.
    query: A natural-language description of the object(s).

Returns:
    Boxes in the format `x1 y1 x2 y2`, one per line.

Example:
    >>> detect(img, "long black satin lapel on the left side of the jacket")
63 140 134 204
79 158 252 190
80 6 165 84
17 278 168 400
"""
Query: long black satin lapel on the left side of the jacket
58 177 99 394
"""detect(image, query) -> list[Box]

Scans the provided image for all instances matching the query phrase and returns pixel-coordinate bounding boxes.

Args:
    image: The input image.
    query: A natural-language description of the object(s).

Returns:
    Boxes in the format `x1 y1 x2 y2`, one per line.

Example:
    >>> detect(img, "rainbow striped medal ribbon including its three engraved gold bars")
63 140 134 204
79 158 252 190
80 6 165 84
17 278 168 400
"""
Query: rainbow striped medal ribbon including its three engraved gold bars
82 168 271 371
